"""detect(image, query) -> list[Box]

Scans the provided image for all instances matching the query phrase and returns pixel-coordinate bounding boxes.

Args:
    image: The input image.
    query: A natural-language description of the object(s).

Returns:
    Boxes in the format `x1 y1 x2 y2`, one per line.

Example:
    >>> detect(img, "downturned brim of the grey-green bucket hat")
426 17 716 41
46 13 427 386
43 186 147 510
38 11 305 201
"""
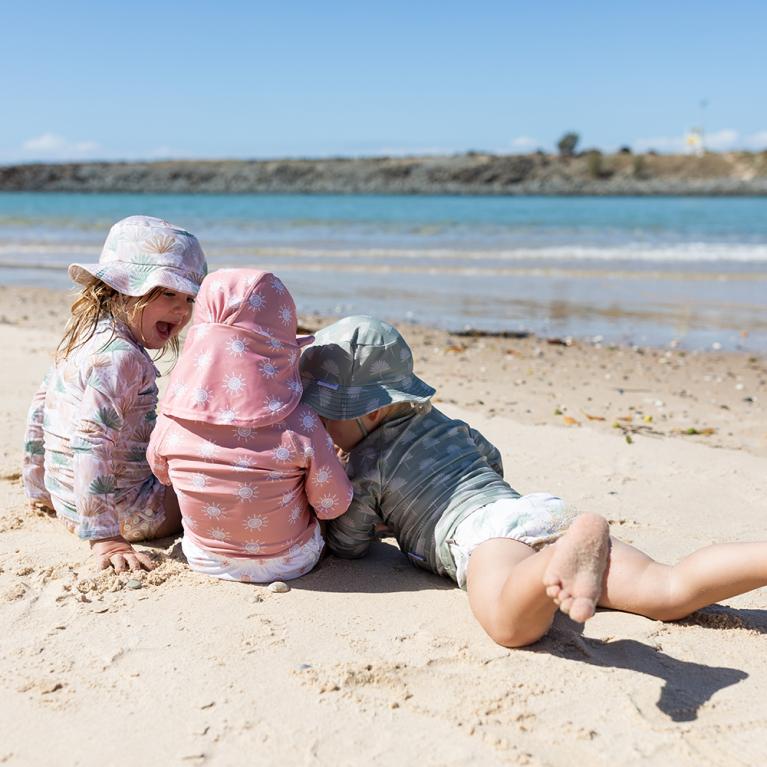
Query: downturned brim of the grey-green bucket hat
301 375 436 421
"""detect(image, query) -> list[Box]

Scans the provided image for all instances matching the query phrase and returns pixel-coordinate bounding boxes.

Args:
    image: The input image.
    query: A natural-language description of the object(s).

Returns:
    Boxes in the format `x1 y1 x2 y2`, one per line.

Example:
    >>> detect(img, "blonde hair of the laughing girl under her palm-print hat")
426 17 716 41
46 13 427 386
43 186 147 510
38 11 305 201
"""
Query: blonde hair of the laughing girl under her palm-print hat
56 277 179 362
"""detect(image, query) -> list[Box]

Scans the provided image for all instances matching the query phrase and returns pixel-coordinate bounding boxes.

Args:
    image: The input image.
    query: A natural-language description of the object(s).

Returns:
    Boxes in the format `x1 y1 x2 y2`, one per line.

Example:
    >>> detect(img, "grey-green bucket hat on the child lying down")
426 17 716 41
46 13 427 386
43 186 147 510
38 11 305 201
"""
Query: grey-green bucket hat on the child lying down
300 315 435 421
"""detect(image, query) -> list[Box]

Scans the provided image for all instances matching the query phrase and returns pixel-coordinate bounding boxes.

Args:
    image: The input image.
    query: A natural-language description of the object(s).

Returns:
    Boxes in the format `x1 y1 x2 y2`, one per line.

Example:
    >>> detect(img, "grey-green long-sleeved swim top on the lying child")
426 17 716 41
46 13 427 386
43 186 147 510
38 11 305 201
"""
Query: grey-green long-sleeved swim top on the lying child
326 404 517 579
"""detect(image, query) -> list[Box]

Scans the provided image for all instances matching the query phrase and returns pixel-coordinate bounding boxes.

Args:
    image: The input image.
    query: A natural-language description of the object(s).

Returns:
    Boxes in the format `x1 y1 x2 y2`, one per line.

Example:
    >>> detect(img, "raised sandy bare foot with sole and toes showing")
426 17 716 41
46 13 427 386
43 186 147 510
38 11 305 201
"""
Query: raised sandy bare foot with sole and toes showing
543 514 610 623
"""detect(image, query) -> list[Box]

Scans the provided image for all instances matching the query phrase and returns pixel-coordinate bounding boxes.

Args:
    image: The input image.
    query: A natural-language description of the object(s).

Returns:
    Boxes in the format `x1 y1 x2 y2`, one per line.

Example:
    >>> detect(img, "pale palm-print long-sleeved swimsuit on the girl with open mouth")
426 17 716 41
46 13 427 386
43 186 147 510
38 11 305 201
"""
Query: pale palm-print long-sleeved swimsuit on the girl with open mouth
24 319 165 540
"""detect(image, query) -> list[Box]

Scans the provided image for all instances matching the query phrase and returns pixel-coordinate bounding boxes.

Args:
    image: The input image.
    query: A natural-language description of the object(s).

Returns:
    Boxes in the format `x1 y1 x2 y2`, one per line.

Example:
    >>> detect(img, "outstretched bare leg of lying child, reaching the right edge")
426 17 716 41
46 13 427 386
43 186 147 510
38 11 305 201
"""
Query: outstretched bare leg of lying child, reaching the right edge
599 539 767 621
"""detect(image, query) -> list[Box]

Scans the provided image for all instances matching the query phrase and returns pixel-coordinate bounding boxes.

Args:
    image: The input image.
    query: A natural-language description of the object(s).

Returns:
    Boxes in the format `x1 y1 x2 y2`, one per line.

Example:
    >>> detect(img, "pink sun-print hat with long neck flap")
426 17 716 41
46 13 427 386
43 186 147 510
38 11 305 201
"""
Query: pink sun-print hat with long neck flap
161 269 314 427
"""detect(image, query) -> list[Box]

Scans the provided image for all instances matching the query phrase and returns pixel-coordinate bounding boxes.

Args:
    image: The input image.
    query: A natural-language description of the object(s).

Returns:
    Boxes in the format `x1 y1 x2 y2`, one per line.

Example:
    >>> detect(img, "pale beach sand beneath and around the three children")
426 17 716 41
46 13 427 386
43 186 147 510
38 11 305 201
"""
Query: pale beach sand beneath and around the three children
0 288 767 767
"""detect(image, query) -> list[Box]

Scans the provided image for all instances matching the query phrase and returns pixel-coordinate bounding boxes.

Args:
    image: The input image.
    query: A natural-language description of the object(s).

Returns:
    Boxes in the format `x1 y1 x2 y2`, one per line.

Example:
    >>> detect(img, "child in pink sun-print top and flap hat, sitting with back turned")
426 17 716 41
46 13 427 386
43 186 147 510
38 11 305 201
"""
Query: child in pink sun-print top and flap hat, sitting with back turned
147 269 352 582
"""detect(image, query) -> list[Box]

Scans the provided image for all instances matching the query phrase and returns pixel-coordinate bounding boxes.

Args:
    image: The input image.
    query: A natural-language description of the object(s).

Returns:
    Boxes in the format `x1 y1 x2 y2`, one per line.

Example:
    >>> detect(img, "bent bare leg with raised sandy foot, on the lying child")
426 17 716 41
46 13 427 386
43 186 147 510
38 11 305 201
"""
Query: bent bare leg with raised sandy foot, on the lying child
466 514 609 647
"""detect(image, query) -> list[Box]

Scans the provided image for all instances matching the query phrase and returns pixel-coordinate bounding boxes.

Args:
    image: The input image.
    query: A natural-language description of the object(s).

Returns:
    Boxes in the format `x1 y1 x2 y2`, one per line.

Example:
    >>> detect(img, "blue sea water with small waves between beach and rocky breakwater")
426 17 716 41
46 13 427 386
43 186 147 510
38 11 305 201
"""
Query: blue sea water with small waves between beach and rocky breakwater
0 193 767 353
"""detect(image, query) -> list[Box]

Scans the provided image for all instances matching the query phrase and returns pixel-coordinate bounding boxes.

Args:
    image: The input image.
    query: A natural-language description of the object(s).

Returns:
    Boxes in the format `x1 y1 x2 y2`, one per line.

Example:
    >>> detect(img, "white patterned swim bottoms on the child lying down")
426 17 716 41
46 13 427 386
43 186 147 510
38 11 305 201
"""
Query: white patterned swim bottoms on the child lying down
449 493 575 589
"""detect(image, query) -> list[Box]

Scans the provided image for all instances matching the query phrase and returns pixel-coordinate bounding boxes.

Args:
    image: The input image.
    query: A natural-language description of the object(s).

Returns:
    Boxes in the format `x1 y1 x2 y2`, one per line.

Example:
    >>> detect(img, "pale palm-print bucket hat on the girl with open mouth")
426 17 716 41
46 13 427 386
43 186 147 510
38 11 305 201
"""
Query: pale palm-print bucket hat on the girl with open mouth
69 216 208 296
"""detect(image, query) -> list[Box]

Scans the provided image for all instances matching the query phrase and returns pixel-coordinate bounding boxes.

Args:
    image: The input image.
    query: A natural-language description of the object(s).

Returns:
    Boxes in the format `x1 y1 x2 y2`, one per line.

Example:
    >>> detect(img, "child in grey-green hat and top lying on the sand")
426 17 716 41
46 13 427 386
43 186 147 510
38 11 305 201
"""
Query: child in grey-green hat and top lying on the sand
301 317 767 647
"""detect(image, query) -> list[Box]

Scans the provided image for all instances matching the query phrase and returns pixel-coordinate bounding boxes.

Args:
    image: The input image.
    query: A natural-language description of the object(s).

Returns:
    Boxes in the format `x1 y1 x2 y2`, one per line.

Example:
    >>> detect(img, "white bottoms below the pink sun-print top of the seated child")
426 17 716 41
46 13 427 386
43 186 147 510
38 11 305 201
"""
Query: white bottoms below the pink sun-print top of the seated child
181 524 325 583
